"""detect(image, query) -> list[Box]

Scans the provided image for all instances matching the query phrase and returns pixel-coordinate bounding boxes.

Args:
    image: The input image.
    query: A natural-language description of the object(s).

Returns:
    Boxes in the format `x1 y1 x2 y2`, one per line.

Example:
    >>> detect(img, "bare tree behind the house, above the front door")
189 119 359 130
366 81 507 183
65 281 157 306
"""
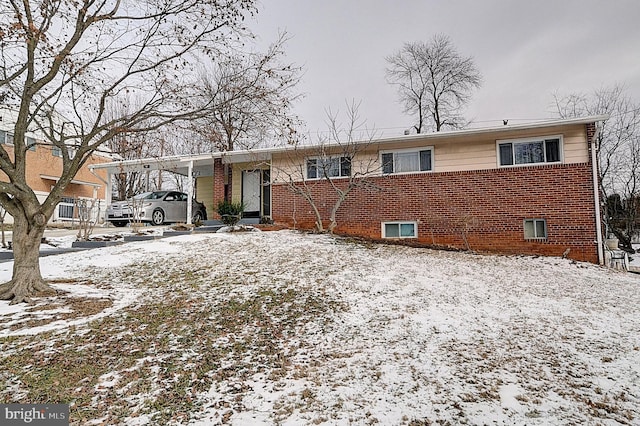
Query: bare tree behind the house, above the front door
197 33 301 151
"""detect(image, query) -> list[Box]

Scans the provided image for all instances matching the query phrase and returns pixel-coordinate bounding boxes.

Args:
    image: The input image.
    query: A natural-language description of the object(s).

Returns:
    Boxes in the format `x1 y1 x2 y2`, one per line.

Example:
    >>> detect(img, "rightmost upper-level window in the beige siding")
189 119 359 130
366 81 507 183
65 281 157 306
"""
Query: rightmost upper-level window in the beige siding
498 136 561 166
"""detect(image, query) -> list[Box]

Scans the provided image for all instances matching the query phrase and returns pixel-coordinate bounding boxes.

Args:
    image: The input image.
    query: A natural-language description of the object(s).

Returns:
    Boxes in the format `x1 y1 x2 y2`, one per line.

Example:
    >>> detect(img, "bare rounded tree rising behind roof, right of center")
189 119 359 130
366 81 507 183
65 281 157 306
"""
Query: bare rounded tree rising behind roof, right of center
386 34 482 133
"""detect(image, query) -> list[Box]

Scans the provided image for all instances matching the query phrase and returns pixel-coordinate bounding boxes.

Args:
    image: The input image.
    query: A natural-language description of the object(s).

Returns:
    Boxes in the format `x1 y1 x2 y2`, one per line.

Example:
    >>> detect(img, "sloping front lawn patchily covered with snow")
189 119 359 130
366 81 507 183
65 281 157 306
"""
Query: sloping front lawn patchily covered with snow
0 231 640 425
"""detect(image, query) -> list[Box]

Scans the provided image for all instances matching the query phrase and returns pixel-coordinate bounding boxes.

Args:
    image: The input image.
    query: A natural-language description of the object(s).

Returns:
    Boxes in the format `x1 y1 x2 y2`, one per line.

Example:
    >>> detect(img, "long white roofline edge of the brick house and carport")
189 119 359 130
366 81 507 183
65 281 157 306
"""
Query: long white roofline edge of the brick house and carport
89 115 609 170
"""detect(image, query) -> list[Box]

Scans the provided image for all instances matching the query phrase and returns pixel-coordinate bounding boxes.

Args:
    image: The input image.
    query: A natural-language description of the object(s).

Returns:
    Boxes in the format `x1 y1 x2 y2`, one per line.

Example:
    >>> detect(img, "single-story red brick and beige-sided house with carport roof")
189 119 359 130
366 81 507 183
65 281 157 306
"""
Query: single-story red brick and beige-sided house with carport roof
89 116 607 263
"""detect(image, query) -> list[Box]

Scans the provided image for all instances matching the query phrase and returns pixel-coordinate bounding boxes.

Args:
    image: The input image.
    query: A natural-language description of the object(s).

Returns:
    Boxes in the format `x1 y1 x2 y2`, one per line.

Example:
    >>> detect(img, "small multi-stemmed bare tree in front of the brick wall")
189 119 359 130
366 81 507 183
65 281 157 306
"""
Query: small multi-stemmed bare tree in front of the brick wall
276 102 382 233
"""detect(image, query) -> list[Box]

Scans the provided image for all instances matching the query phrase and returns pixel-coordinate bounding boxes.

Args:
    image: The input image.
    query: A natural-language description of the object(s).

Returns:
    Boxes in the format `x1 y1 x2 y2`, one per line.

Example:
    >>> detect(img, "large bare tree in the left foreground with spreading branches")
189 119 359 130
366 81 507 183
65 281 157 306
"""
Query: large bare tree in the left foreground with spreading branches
0 0 255 303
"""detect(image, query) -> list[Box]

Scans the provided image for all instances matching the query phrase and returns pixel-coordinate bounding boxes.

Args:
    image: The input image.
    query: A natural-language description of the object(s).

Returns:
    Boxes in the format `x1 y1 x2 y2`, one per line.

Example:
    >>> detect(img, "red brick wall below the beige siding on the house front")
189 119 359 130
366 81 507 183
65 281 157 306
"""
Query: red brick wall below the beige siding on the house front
272 163 598 263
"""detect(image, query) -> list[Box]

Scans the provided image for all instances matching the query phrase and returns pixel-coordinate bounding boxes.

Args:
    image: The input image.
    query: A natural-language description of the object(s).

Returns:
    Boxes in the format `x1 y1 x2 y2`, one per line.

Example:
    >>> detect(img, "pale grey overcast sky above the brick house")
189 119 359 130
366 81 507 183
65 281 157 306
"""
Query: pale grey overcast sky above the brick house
250 0 640 136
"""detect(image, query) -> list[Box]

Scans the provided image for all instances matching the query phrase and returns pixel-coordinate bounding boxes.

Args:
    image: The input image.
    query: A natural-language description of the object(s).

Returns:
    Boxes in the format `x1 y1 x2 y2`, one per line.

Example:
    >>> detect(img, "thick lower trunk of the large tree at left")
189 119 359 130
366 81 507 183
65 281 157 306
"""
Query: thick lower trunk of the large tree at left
0 215 54 304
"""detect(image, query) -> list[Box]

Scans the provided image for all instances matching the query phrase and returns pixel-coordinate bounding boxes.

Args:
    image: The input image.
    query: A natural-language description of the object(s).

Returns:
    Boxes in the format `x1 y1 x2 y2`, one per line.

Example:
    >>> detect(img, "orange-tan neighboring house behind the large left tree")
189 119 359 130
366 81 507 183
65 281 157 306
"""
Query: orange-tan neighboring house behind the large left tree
0 110 112 223
